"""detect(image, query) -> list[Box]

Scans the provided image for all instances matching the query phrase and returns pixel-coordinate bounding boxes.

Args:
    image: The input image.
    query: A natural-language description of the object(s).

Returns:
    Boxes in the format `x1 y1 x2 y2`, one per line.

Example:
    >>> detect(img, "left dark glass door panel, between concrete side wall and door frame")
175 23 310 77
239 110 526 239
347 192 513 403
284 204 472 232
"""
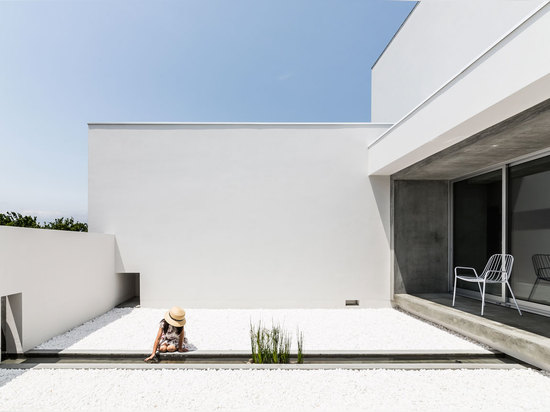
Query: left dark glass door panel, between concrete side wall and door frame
453 169 502 297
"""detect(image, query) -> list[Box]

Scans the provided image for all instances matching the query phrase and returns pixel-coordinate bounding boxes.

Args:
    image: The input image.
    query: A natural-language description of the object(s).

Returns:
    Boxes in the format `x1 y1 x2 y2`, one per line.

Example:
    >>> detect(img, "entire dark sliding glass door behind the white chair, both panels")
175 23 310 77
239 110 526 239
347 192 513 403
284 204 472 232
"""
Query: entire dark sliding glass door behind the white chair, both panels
450 156 550 314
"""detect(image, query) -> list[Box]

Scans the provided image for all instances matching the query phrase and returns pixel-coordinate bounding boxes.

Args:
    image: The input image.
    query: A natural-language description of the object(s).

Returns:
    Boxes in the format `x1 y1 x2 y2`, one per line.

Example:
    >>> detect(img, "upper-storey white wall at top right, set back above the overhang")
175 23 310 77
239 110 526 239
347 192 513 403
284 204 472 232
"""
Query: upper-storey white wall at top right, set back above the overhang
371 0 544 123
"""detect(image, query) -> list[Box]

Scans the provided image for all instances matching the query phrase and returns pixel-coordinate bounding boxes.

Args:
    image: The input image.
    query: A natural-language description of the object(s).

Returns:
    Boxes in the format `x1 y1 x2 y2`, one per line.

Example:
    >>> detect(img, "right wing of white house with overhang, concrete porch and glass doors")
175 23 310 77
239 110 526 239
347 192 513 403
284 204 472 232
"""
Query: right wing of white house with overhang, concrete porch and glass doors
368 2 550 313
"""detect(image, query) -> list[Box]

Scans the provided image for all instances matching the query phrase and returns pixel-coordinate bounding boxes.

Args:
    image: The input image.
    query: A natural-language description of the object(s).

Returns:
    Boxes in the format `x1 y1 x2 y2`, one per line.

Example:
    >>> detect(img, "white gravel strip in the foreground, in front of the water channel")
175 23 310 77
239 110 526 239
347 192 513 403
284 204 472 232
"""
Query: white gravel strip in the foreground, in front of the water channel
0 369 550 412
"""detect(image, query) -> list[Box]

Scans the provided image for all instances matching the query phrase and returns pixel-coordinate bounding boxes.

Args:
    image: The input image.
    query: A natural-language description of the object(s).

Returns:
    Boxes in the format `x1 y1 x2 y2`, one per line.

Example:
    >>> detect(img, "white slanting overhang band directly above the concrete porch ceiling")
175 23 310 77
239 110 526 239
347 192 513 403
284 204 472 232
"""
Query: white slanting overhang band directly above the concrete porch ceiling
369 4 550 175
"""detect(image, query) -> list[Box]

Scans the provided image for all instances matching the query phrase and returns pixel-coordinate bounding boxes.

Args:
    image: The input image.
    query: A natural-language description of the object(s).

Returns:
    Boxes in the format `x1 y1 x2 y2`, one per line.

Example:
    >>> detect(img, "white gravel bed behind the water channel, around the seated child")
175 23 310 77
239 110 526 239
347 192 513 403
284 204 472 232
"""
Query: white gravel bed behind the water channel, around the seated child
37 308 482 352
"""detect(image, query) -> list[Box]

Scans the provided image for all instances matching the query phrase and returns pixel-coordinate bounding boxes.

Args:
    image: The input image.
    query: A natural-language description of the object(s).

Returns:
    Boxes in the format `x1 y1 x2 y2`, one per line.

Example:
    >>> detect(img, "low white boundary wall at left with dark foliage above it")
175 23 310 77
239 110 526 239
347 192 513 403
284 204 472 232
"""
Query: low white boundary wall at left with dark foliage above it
0 226 132 350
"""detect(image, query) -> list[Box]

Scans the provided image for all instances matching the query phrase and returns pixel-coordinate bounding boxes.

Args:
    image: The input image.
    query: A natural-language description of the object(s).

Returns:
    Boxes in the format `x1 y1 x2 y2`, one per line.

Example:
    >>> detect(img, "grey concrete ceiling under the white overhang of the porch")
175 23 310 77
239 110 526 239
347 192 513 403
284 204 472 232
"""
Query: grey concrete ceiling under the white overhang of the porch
392 99 550 180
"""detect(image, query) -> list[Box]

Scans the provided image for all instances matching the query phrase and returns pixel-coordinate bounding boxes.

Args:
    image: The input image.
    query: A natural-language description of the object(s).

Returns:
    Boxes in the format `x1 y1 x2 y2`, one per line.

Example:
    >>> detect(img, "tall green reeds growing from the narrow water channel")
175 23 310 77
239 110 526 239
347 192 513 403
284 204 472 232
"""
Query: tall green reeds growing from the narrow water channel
250 321 303 363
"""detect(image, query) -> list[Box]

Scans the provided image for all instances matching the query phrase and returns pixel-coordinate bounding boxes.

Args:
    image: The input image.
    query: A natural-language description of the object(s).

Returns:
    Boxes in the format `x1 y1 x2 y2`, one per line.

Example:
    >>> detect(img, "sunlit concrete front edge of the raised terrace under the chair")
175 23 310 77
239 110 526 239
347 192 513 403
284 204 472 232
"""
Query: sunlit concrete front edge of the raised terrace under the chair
393 294 550 370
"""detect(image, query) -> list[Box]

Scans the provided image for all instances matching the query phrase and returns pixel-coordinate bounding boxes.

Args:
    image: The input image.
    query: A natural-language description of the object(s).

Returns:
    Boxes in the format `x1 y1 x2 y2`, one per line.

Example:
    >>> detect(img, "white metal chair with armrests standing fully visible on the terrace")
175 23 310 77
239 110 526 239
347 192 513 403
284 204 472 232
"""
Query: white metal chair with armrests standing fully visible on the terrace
453 254 521 316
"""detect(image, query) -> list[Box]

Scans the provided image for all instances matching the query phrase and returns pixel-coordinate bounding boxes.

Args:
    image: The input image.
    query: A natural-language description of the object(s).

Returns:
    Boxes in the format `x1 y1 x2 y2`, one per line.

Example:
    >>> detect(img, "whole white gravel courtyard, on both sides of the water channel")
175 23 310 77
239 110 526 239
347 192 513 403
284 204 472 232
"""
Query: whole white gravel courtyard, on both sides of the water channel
4 308 550 411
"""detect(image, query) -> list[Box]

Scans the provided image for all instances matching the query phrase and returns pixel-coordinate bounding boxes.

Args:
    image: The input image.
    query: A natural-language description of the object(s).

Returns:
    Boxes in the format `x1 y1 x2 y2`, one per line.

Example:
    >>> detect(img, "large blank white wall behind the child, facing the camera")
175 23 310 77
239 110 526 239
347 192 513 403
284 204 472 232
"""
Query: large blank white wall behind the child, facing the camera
89 124 390 308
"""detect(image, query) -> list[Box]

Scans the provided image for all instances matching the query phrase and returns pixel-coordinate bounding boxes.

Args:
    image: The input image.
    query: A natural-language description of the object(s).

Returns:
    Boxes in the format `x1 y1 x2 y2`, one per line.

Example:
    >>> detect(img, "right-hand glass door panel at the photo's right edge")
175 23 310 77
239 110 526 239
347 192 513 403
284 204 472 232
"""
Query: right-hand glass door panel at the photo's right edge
508 156 550 304
